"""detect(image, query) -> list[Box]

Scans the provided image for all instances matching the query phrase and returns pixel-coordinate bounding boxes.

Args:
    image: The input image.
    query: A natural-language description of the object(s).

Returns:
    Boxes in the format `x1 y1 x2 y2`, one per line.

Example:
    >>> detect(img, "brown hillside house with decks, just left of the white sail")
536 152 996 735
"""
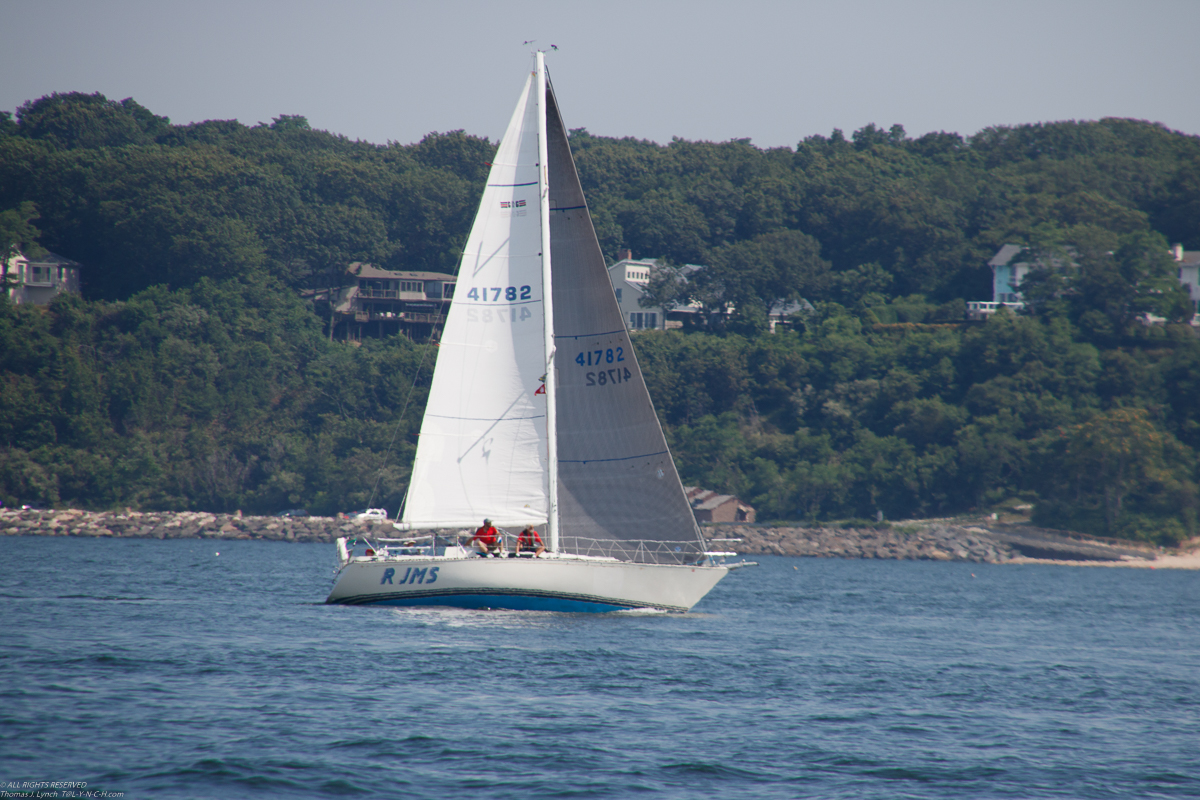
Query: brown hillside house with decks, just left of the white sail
324 261 456 341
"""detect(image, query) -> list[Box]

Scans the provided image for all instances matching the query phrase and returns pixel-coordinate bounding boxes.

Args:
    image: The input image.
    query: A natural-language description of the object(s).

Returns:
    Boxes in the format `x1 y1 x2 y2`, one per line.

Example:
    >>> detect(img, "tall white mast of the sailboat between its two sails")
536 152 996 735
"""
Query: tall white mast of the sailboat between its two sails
536 50 558 553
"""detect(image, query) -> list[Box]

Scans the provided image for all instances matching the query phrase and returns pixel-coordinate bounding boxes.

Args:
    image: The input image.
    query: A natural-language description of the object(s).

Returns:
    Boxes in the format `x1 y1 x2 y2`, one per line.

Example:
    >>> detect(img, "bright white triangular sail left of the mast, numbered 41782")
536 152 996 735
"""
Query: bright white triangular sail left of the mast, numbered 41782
401 74 547 528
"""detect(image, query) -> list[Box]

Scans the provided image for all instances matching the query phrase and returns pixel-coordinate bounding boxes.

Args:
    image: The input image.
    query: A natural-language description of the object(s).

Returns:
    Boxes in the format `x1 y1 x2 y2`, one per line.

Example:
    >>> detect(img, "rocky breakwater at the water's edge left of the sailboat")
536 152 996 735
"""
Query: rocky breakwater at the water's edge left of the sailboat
0 509 395 542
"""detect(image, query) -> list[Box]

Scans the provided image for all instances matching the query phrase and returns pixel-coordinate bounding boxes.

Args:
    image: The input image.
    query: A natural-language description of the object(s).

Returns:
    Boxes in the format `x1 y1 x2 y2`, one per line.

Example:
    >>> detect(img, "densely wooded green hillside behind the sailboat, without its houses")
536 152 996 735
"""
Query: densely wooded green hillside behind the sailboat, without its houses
0 94 1200 540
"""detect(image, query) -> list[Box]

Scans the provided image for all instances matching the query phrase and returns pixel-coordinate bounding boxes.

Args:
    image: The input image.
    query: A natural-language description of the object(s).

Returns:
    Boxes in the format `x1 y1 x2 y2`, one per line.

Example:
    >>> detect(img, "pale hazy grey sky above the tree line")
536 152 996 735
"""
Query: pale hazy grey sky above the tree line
0 0 1200 146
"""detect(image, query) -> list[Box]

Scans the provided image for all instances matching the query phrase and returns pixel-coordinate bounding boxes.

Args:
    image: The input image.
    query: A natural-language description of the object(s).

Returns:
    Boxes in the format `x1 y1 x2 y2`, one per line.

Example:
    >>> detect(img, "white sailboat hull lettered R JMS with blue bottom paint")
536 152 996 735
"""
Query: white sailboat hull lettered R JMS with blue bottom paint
325 555 728 612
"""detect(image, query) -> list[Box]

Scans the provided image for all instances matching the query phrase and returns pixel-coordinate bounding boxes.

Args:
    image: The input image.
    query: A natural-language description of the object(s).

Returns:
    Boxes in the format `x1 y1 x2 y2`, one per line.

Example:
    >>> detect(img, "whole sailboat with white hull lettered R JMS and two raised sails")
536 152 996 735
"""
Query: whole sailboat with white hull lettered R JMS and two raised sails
326 52 740 612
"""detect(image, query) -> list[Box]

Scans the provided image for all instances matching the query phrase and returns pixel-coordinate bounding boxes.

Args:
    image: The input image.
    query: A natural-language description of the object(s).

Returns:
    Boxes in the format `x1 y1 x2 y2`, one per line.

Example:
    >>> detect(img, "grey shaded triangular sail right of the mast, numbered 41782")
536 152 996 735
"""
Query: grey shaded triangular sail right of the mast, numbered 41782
546 81 703 561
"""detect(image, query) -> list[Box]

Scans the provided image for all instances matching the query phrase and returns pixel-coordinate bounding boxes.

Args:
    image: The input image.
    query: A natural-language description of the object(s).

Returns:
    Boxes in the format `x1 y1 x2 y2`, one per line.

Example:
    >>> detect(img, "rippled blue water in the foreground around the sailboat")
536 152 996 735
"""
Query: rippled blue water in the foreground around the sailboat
0 537 1200 799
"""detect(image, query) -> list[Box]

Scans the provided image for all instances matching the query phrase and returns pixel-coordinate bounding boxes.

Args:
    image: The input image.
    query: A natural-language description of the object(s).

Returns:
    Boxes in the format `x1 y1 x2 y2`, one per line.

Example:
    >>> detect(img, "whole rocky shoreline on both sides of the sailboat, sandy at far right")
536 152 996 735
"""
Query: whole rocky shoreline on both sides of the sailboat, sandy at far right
0 509 1200 570
